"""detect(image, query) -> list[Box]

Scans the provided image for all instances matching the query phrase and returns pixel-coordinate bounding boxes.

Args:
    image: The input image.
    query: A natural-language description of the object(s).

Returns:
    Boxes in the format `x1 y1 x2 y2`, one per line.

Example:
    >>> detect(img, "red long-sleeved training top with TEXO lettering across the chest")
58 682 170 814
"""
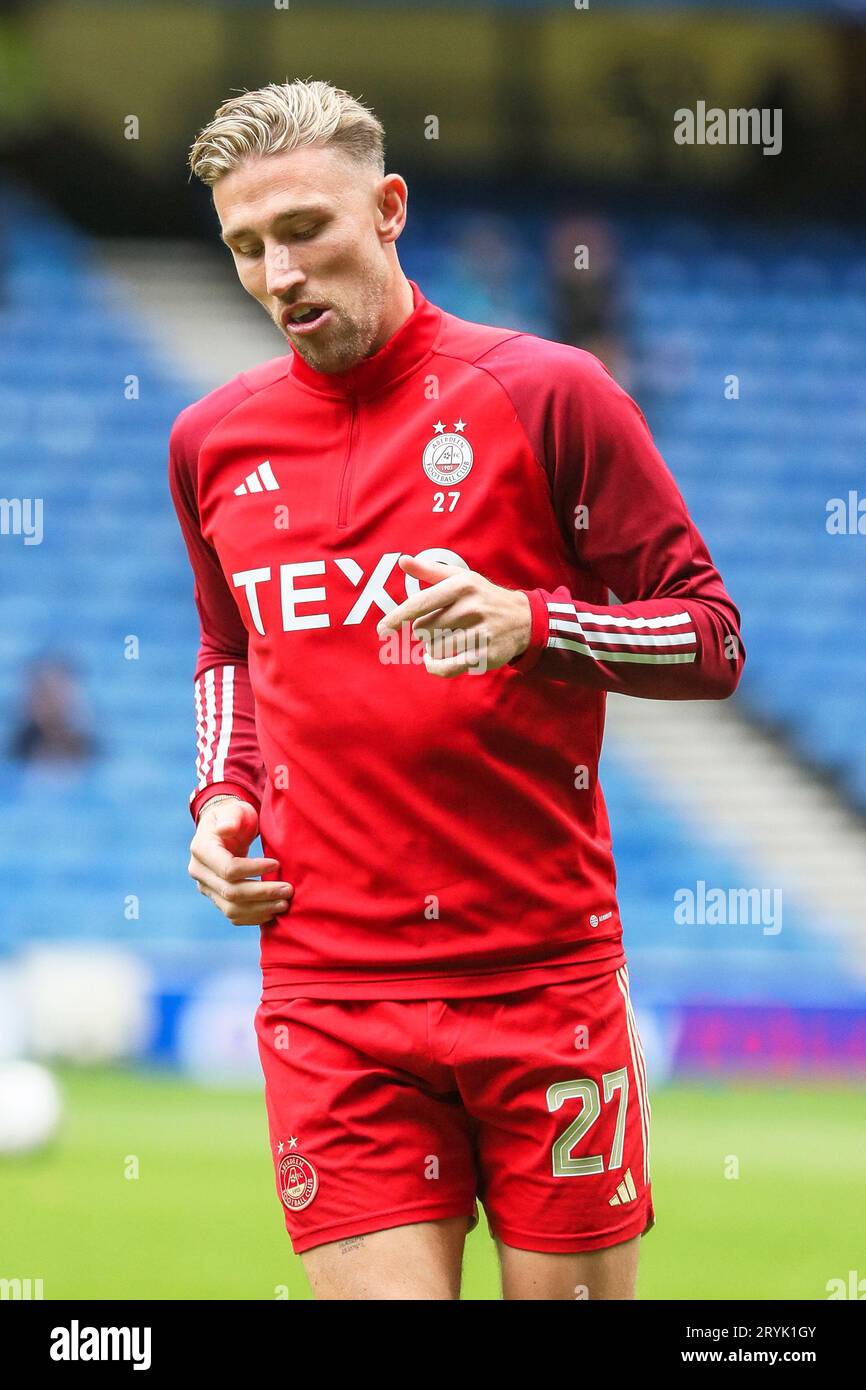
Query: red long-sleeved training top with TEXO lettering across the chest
171 285 742 998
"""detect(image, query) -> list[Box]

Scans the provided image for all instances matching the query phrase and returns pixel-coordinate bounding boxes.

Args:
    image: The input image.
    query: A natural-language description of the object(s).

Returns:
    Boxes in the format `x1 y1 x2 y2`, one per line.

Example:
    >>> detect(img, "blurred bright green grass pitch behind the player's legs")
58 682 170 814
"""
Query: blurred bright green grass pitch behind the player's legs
0 1070 866 1300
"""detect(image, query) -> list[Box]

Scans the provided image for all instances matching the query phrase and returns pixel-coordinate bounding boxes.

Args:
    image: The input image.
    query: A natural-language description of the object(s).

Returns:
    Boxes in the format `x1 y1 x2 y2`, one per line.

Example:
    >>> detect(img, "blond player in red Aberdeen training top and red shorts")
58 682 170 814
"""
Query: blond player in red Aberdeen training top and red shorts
171 82 744 1298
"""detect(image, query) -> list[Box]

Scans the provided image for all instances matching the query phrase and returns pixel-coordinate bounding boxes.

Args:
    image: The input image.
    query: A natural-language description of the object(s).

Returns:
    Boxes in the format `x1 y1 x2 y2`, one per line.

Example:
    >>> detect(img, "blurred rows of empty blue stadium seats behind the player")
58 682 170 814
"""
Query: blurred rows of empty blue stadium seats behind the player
0 182 866 1023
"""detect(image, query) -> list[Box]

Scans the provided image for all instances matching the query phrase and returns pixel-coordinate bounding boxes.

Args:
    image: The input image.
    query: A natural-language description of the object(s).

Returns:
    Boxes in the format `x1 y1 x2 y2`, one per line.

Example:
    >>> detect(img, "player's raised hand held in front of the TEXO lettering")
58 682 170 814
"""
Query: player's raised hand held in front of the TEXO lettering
377 555 532 676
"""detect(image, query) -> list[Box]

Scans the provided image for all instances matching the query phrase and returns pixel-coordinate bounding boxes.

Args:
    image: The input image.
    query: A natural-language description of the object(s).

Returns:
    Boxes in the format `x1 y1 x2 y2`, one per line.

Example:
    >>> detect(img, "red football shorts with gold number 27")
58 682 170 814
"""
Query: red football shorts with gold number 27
256 966 653 1252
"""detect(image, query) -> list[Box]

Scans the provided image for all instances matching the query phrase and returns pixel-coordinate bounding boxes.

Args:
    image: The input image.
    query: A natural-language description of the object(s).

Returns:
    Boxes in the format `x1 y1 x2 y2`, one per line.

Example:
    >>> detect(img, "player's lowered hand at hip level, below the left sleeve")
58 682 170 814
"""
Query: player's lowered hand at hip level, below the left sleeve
188 796 293 927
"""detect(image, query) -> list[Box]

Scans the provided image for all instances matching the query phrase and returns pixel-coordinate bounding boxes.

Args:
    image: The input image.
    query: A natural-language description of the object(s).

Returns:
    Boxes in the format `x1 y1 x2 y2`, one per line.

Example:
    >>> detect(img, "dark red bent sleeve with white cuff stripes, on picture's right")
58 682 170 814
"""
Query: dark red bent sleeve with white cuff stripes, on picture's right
478 342 745 699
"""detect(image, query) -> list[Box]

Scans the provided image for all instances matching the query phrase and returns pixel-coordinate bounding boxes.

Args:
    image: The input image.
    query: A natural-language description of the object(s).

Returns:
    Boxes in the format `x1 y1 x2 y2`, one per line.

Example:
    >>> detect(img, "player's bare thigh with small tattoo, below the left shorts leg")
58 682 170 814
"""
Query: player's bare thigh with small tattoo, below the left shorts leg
300 1216 470 1301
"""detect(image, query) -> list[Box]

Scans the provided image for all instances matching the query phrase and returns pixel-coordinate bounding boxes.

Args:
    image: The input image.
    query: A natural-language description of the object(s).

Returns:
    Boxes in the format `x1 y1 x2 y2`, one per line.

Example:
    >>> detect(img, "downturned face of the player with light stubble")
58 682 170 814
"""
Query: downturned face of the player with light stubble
214 146 406 371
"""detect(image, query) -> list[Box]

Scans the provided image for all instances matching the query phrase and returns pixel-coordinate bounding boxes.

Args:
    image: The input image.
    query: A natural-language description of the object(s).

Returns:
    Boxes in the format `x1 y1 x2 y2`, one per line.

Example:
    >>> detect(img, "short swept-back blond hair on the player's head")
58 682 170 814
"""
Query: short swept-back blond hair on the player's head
189 78 385 188
